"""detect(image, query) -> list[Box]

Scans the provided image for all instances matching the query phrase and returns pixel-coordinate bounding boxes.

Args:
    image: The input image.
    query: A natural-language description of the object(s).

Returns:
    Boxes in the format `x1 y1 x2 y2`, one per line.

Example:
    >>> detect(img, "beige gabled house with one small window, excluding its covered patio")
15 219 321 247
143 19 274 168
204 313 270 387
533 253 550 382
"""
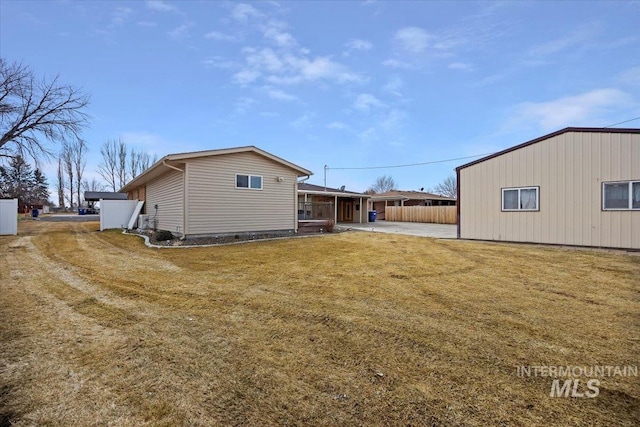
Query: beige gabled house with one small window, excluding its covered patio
120 146 311 237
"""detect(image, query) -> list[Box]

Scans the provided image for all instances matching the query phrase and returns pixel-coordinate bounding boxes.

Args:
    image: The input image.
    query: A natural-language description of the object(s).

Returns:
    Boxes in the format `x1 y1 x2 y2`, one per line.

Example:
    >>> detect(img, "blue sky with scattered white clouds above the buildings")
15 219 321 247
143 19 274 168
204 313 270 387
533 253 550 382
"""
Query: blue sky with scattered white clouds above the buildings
0 0 640 196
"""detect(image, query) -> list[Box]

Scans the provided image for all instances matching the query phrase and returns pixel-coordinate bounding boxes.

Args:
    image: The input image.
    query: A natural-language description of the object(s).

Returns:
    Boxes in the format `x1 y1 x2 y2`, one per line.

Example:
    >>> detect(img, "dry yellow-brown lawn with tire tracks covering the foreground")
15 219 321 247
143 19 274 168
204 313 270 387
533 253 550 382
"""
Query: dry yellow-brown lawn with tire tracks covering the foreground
0 221 640 426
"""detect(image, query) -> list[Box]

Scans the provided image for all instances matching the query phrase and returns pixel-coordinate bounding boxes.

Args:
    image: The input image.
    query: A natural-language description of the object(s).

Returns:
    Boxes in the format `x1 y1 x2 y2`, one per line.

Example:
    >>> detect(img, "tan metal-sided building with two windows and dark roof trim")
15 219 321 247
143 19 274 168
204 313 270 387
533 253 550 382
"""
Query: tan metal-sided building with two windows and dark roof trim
456 128 640 249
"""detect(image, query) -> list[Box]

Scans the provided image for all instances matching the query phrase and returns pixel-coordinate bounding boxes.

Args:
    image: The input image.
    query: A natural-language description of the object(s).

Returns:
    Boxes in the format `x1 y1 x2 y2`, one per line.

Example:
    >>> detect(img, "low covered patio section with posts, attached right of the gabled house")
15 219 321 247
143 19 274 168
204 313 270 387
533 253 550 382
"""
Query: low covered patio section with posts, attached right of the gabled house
298 183 370 223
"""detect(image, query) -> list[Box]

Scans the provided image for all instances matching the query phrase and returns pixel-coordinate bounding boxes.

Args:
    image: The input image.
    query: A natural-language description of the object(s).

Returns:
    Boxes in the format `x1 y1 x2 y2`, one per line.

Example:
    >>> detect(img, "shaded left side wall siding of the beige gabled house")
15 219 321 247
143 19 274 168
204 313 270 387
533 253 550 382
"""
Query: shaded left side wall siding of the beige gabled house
145 168 184 234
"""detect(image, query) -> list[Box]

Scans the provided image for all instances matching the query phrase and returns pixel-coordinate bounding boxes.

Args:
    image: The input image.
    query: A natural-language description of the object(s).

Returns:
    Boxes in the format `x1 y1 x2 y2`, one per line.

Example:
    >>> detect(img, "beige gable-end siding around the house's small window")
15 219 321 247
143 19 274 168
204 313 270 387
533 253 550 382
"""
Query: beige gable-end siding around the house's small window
182 152 297 236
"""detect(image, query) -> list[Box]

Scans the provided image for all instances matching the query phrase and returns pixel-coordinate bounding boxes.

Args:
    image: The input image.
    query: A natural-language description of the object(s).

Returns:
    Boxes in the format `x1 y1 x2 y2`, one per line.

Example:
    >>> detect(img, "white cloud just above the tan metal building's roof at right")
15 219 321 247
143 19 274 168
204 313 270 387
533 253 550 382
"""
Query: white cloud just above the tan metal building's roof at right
507 89 633 130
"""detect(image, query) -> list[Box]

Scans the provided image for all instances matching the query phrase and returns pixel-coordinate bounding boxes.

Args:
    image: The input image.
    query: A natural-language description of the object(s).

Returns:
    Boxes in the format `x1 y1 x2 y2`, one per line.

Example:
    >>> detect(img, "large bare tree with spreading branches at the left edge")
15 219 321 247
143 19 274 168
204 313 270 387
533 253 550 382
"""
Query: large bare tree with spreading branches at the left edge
0 58 89 159
